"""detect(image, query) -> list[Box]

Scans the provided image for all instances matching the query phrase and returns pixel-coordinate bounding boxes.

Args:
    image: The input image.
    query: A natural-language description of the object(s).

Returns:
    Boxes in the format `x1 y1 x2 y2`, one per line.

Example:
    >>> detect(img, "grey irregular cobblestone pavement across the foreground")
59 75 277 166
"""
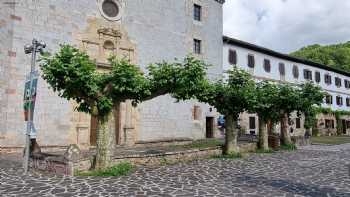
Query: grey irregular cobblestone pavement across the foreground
0 145 350 197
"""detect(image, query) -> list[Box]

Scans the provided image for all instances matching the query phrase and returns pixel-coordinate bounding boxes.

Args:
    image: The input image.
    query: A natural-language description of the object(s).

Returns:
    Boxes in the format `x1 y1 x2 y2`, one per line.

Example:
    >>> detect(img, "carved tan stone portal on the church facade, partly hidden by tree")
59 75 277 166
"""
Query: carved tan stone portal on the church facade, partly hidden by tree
73 18 138 146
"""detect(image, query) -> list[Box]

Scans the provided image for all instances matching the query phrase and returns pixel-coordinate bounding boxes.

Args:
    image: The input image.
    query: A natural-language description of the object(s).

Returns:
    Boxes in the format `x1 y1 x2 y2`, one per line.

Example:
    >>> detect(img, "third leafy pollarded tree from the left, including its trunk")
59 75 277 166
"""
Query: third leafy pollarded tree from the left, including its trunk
250 81 280 150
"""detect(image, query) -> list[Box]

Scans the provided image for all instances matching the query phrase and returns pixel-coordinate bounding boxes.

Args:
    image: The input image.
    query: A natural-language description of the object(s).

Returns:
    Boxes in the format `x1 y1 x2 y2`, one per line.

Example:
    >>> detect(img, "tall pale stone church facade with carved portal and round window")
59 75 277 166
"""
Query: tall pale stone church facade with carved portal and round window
0 0 224 151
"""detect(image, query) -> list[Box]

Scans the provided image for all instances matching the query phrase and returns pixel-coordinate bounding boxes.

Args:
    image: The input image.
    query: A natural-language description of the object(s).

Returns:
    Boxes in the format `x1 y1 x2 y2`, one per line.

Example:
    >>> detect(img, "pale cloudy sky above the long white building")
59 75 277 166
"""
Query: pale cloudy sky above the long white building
224 0 350 53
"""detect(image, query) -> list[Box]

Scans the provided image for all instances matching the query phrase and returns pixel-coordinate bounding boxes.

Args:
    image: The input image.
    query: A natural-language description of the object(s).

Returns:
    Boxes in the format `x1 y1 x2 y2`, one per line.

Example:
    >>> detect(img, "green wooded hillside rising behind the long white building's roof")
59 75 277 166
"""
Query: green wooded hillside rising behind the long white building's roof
291 41 350 72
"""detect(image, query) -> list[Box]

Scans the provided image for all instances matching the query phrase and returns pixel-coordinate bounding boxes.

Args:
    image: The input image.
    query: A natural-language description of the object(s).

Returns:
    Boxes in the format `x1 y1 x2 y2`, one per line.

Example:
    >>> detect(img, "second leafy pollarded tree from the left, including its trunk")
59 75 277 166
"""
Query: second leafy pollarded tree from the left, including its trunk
197 67 255 154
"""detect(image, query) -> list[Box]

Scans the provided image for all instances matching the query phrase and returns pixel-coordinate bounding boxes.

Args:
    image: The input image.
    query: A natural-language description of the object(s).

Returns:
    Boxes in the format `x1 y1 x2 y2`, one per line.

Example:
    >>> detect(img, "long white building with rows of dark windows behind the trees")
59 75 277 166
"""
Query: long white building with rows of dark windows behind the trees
223 36 350 135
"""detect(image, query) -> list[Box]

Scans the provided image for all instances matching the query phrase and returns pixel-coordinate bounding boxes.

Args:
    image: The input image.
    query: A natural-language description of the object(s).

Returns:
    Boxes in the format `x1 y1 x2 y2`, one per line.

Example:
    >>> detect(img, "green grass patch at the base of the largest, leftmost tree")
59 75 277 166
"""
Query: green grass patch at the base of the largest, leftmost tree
76 162 134 177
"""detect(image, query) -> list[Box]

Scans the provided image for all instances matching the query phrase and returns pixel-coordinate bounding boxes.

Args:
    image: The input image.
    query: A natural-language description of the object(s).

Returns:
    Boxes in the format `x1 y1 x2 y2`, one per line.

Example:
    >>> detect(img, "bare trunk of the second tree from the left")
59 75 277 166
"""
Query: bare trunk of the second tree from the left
224 115 239 155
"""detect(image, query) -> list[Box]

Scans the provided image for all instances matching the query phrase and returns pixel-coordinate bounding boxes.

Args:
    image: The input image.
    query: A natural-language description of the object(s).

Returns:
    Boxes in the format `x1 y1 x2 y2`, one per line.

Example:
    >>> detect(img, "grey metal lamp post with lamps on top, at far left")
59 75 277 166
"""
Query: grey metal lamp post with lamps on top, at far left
23 39 46 174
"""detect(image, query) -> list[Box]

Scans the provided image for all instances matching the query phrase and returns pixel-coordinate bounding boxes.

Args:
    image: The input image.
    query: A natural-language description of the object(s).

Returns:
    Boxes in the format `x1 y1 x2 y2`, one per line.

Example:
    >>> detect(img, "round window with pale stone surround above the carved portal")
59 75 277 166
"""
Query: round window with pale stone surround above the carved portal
99 0 122 21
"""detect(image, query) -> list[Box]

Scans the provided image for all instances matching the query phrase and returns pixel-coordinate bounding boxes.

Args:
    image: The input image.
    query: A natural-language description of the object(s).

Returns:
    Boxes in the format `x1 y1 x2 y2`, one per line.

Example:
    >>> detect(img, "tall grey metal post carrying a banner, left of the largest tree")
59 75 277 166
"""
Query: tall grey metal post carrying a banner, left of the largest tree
23 39 46 174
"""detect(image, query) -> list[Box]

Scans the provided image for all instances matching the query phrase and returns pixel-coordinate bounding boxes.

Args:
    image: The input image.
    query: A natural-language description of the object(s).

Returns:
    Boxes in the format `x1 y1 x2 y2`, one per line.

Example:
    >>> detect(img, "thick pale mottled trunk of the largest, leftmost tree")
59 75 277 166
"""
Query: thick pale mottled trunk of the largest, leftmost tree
93 112 115 170
